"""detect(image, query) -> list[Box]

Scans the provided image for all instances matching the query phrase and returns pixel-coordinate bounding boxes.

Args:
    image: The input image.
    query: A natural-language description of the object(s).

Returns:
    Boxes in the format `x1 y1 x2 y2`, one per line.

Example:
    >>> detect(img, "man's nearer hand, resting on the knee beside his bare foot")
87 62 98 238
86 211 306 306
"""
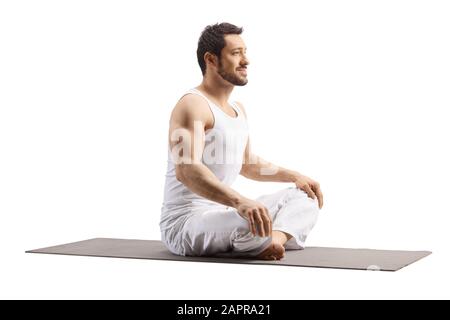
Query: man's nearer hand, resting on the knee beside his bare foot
236 198 272 237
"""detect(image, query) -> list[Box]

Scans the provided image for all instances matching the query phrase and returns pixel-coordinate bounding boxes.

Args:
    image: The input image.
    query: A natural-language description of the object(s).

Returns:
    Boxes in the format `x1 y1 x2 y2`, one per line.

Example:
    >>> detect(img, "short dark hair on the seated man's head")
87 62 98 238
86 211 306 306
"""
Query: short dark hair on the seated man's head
197 22 244 75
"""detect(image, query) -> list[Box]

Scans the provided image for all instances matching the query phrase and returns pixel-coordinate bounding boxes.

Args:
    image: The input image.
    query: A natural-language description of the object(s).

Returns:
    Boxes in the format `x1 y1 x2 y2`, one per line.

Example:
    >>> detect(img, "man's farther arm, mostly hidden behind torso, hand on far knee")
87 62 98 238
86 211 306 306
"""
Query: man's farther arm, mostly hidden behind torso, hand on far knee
239 103 323 208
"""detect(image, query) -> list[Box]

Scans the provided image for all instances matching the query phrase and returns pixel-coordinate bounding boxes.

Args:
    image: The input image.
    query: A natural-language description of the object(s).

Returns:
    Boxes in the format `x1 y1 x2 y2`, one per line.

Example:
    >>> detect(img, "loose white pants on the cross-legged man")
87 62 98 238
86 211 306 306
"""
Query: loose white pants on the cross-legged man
161 187 319 257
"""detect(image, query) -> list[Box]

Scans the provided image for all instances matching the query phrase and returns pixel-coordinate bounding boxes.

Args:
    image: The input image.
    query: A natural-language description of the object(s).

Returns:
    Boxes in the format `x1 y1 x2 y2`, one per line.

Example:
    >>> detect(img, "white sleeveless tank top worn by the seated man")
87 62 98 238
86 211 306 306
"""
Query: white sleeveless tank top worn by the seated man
162 89 248 209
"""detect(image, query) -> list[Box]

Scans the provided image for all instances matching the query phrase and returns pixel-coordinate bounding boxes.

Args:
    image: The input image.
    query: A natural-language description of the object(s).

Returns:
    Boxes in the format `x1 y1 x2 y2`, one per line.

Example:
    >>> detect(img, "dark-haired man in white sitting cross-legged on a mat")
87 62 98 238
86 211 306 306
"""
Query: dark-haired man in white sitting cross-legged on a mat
160 23 323 260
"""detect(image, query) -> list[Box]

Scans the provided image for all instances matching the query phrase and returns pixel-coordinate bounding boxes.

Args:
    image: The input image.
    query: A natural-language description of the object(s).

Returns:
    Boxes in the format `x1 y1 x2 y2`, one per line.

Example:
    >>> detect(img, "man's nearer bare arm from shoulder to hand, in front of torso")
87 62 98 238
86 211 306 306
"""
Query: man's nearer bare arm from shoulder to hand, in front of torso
169 95 272 237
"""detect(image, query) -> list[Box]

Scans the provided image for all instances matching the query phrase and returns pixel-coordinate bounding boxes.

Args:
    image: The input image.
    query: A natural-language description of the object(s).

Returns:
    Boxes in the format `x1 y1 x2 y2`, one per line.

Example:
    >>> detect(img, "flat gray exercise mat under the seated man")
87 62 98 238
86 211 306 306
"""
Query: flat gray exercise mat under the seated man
26 238 431 271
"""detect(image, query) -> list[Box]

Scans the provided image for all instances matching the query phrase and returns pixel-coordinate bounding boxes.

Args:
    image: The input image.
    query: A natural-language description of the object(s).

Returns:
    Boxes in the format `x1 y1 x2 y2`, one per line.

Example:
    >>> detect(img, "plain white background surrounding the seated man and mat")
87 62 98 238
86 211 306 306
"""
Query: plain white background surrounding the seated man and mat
0 0 450 299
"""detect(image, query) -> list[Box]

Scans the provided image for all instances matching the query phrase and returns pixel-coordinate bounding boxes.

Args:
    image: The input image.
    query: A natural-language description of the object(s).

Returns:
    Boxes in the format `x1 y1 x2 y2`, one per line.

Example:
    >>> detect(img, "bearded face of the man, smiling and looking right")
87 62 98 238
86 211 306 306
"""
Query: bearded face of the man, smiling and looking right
217 34 250 86
